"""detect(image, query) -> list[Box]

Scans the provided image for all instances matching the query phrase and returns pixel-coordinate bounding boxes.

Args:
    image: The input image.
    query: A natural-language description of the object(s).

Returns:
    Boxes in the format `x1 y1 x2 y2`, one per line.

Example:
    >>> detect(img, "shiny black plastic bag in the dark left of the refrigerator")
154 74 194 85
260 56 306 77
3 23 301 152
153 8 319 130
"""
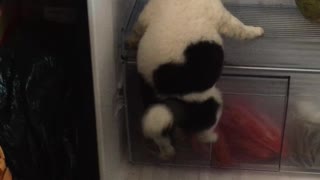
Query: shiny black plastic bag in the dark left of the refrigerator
0 48 77 179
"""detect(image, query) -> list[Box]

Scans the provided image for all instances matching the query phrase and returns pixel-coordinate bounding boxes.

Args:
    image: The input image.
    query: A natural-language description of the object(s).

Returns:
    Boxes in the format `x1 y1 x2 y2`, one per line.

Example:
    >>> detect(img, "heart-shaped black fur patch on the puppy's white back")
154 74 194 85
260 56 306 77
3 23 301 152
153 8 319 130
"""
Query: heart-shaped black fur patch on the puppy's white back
153 41 224 95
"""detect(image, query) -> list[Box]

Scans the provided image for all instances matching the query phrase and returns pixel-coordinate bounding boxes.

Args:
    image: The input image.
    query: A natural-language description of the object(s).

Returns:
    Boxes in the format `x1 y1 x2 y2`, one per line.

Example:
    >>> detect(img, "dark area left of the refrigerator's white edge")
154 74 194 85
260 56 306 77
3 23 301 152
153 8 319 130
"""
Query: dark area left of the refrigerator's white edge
0 0 99 180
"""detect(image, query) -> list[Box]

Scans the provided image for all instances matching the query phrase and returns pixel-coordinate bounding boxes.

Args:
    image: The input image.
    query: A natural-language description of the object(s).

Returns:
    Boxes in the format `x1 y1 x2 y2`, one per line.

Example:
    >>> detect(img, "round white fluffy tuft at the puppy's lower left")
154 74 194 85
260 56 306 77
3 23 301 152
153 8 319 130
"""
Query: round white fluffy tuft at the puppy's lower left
142 104 174 140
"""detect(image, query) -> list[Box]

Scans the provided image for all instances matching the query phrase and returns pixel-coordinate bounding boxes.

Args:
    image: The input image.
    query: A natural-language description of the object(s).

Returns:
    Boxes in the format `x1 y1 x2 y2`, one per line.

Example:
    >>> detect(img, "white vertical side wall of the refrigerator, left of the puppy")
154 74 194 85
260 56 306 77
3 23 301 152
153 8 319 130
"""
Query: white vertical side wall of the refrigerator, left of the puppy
88 0 133 180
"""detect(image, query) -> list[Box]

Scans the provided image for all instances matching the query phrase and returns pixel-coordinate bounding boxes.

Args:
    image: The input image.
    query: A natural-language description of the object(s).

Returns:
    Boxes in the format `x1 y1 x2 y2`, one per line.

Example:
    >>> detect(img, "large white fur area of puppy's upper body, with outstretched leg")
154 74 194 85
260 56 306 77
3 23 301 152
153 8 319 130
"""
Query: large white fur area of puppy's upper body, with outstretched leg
130 0 264 84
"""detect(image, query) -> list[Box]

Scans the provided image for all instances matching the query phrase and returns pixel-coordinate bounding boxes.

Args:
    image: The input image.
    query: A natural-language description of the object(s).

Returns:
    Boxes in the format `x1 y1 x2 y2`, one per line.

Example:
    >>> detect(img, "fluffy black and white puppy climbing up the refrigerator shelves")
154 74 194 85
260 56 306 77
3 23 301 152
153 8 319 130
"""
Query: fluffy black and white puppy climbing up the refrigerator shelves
127 0 264 159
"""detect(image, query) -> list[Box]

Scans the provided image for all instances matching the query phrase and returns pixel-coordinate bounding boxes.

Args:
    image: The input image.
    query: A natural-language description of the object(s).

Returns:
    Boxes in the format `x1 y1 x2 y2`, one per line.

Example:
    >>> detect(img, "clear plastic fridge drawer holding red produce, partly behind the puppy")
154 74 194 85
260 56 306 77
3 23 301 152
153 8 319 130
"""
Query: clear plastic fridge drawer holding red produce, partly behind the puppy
125 63 289 171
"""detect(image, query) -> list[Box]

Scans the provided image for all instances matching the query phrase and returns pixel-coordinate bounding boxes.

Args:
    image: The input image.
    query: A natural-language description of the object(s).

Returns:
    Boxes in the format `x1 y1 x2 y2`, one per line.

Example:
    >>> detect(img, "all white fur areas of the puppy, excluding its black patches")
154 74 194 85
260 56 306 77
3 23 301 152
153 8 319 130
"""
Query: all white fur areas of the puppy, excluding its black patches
128 0 264 157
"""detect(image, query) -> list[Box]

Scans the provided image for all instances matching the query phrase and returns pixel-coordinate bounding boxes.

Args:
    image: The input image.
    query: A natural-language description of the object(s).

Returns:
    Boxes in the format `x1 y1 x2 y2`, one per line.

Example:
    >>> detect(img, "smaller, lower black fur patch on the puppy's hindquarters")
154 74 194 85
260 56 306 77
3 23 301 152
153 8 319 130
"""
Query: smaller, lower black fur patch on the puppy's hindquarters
163 98 220 133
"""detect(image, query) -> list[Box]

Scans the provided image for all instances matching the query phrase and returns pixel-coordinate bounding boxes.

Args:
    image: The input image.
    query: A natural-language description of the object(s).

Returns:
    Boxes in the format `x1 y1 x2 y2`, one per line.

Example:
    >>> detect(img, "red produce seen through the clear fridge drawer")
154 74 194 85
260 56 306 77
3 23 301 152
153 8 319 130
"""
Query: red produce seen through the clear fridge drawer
193 99 287 167
